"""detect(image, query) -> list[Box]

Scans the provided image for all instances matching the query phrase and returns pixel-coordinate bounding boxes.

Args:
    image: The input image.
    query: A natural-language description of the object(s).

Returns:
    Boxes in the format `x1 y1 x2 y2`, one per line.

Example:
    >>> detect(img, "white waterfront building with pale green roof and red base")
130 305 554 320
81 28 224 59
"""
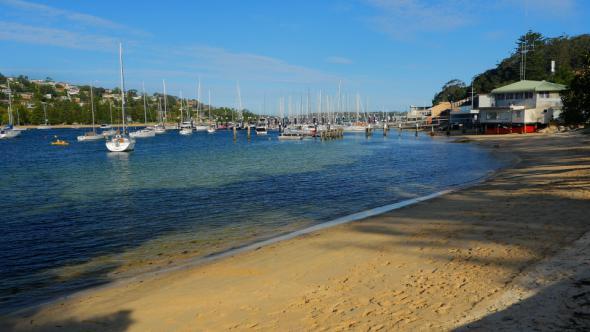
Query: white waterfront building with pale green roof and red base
479 80 565 134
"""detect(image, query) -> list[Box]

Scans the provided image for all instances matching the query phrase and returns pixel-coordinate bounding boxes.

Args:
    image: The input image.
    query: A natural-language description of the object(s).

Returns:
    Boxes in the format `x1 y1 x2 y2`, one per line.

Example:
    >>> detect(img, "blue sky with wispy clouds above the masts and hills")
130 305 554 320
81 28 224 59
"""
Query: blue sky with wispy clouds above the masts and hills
0 0 590 113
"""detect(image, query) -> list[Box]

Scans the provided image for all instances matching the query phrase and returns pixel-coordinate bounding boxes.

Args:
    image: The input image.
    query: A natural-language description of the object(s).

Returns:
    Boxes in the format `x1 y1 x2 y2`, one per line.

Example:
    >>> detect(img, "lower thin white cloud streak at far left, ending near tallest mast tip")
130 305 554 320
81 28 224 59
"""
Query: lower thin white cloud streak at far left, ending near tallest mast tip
0 21 118 51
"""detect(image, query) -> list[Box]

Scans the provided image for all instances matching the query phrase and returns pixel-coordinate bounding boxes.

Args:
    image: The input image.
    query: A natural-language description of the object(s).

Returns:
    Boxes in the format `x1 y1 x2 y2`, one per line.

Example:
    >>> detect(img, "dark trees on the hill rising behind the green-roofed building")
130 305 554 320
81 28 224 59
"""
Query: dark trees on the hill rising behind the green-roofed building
432 31 590 104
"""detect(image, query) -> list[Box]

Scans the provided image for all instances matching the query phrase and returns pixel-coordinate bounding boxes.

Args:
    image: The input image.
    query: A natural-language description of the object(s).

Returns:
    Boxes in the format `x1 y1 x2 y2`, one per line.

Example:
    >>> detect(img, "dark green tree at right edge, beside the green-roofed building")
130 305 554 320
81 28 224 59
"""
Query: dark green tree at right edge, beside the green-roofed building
560 53 590 124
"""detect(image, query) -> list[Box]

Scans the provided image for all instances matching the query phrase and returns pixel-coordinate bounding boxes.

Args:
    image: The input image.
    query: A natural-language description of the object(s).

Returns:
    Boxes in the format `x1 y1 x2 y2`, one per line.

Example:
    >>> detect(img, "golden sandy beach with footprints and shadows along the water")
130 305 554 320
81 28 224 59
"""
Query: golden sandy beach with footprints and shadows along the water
0 133 590 331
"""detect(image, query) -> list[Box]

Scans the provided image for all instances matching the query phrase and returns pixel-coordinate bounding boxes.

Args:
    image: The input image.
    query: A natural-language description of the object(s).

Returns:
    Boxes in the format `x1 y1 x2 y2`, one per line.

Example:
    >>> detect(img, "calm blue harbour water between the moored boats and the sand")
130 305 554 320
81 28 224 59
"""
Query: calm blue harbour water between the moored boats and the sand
0 129 501 310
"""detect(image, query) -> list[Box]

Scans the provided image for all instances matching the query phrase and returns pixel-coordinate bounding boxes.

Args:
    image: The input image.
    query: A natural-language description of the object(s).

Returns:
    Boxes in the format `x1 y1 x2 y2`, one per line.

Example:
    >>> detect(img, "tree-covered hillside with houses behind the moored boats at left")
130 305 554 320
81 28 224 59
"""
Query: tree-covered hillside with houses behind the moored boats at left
0 74 256 125
